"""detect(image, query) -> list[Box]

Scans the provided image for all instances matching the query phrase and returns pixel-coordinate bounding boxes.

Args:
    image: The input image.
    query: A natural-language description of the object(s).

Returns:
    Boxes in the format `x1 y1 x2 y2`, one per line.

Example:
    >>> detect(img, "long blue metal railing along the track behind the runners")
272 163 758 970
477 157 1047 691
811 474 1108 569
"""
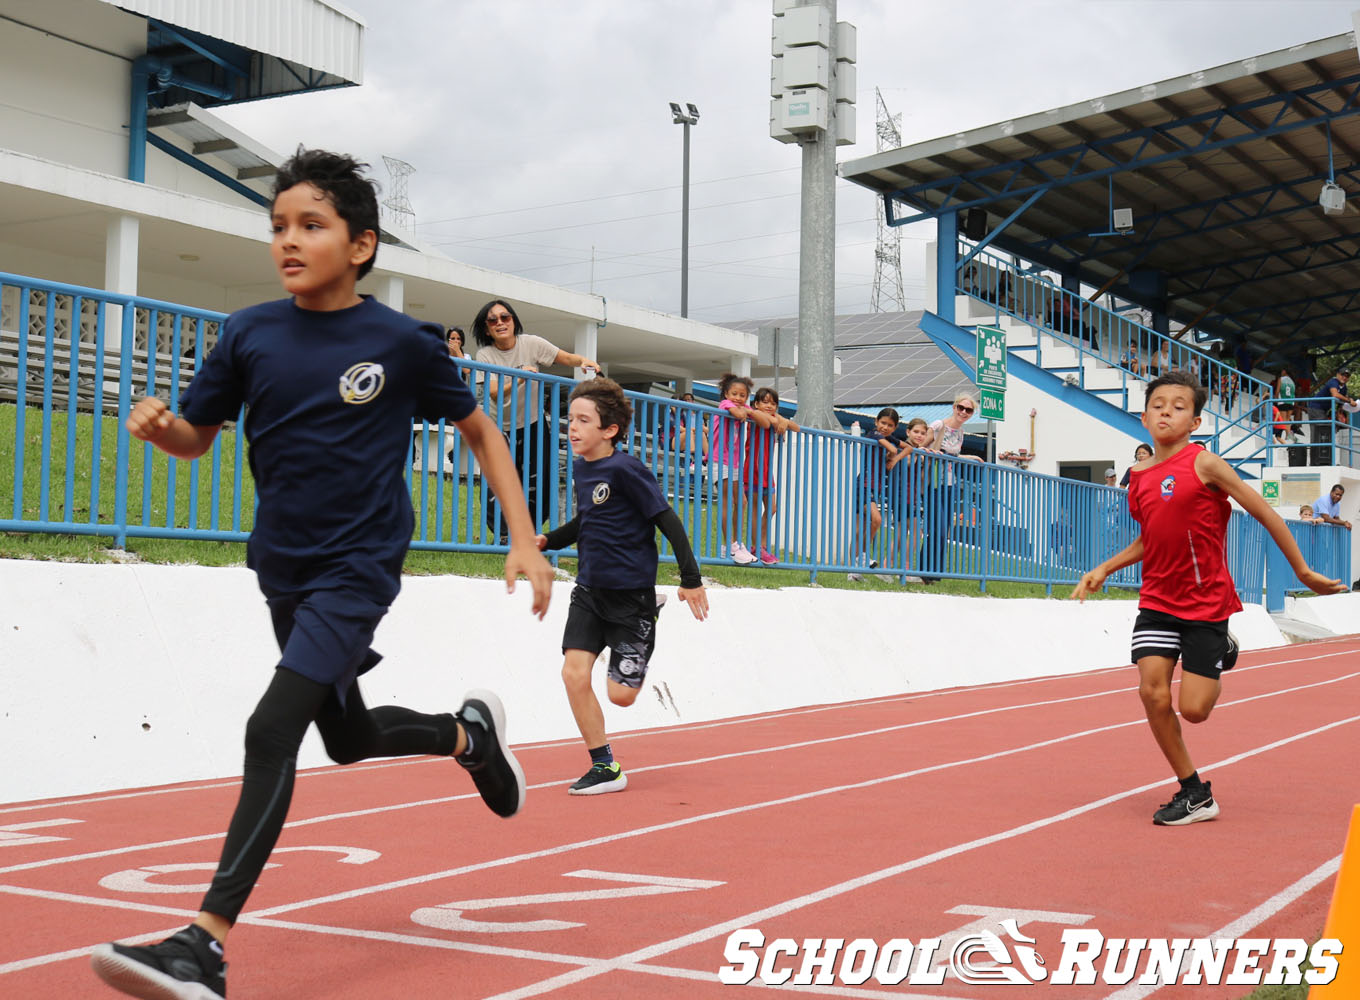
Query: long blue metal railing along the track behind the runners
0 273 1349 600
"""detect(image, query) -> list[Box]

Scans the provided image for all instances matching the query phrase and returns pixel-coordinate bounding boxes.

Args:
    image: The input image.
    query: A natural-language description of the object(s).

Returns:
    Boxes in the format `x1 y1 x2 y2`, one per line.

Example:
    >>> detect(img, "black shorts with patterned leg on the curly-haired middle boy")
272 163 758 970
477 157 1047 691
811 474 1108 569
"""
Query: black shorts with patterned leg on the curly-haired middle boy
562 584 661 687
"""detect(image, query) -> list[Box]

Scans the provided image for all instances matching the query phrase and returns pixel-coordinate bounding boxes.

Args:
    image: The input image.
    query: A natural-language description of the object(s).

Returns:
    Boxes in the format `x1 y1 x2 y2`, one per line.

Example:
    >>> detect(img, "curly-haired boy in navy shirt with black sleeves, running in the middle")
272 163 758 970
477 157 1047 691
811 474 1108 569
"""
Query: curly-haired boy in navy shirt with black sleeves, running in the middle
537 378 709 795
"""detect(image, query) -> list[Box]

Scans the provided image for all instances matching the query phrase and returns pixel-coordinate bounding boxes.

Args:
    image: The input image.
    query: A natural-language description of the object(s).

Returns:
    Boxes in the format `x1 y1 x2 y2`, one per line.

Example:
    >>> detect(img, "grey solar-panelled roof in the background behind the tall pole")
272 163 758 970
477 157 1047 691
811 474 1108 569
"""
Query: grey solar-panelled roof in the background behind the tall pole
724 310 975 410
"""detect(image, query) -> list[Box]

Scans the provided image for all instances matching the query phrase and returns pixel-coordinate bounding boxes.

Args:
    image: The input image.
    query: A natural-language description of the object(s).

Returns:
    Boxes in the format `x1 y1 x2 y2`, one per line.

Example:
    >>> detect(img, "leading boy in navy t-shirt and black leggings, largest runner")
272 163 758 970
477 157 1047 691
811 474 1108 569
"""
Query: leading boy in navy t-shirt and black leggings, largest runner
92 150 552 1000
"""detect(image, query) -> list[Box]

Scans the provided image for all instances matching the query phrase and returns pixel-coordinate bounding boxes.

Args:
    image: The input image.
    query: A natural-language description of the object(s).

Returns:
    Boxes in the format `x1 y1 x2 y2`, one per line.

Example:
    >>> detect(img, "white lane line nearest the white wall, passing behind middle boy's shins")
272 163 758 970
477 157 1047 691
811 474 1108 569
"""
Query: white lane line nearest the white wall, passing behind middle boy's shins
0 639 1360 815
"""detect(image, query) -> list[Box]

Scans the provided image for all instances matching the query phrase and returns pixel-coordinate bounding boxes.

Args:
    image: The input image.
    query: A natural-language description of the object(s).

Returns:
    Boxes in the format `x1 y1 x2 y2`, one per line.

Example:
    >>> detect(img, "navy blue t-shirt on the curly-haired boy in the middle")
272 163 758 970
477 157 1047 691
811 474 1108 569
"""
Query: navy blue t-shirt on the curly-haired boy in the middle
571 452 670 590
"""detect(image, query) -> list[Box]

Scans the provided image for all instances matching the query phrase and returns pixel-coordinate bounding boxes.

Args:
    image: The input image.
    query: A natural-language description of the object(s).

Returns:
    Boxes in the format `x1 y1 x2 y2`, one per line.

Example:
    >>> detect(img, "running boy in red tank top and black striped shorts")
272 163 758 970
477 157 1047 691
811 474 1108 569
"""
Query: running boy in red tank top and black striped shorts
1072 371 1346 826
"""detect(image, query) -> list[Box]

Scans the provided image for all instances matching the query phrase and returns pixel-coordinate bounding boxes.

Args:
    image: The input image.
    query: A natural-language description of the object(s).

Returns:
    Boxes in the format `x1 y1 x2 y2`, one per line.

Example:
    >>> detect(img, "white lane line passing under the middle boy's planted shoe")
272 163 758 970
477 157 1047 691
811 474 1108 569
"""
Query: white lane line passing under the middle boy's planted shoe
0 671 1360 875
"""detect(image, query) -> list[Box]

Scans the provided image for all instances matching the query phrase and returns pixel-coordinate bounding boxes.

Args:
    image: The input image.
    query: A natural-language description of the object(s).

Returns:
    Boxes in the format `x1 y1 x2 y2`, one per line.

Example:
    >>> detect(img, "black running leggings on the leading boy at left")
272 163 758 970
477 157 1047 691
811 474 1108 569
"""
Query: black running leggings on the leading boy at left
203 667 458 924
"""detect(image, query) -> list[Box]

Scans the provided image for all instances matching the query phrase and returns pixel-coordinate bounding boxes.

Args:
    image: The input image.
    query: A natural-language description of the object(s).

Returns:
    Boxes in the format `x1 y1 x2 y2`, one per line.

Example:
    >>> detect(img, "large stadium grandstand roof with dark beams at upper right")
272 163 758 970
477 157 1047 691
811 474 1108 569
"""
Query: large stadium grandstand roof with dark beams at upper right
839 34 1360 364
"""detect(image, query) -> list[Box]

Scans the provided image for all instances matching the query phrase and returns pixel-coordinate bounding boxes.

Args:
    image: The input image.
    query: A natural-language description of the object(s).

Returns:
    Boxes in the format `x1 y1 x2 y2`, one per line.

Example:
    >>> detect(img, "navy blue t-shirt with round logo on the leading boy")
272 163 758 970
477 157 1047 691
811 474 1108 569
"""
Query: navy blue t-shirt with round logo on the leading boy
180 297 477 604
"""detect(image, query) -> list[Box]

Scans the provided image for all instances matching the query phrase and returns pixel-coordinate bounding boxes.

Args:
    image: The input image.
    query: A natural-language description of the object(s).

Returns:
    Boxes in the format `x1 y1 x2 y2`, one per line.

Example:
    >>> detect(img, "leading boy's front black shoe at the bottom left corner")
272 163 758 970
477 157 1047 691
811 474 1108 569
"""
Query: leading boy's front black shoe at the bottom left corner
90 924 227 1000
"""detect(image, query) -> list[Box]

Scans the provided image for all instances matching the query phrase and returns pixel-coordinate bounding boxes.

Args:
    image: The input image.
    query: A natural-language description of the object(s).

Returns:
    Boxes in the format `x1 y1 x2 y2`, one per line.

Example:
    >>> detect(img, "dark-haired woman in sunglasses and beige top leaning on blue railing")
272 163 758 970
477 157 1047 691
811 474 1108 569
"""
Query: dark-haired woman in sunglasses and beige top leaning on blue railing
472 299 600 539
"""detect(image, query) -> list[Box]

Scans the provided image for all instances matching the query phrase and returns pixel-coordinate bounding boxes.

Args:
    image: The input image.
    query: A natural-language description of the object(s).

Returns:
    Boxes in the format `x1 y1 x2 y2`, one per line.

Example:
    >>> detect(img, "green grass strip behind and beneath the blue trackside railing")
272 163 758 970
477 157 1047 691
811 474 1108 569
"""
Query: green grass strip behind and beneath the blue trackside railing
0 405 1136 600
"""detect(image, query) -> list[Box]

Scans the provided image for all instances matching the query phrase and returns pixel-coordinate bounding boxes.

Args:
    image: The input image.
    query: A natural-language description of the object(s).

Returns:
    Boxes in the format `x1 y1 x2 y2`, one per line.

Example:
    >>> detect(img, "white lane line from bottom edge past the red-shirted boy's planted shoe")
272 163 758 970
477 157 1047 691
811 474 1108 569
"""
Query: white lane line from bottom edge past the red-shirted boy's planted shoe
473 716 1360 1000
